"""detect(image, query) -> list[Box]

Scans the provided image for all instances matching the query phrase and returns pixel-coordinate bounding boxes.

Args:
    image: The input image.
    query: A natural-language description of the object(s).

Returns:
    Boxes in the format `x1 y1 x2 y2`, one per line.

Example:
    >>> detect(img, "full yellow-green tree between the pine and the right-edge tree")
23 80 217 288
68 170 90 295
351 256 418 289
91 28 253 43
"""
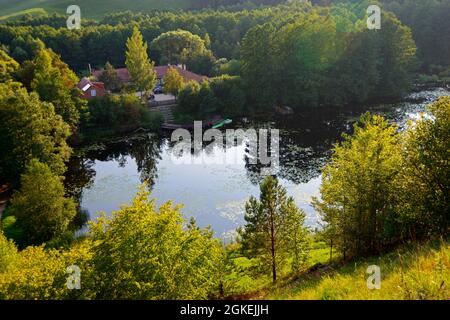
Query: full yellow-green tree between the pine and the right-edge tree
313 114 401 257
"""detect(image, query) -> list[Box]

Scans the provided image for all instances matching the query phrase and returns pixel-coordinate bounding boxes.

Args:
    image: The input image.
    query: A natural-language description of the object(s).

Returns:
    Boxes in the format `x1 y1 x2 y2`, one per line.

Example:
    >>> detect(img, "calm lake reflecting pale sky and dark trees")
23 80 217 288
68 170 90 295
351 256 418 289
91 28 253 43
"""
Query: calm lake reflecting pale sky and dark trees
66 88 450 240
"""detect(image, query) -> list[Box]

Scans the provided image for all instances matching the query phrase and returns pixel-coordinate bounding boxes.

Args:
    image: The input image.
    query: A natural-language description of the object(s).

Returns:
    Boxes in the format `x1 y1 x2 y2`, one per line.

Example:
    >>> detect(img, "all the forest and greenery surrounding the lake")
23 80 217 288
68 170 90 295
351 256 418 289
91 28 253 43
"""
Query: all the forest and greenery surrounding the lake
0 0 450 300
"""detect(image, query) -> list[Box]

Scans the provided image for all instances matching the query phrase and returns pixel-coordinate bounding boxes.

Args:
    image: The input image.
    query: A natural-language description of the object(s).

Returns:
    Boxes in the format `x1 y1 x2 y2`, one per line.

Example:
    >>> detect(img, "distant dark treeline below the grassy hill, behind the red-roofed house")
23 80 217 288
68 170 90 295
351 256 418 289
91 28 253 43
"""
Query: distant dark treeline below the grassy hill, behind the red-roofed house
0 5 312 71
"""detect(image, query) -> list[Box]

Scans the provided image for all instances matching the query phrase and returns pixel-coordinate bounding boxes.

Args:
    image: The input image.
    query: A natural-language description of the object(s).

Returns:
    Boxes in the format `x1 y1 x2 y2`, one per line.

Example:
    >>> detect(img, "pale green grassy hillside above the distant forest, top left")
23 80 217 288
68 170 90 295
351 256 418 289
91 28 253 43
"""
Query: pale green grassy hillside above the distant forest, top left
0 0 193 18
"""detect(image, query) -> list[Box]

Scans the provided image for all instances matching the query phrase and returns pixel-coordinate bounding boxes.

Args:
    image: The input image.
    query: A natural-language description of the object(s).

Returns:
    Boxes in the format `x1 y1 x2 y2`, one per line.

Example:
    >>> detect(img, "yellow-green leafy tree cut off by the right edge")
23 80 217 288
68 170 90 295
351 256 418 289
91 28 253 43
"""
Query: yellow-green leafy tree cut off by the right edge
396 97 450 237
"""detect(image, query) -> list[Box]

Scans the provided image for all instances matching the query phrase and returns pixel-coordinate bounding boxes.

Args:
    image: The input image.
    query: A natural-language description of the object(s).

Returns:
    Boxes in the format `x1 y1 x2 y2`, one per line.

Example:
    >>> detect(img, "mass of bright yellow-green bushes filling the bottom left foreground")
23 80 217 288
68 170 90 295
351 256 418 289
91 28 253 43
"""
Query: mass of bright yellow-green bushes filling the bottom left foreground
0 189 223 299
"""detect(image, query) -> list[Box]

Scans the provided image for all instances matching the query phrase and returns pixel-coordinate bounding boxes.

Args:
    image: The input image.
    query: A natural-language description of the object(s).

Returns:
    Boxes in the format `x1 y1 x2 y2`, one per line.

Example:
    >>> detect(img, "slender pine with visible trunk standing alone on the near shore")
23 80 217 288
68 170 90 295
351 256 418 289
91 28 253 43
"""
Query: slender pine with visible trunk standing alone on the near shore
239 176 307 282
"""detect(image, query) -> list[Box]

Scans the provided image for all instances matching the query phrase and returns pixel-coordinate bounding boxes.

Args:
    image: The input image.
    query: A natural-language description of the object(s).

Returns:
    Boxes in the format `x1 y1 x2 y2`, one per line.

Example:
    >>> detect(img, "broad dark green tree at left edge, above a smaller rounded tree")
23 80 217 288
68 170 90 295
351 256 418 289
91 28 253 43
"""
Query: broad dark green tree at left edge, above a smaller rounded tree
0 82 71 185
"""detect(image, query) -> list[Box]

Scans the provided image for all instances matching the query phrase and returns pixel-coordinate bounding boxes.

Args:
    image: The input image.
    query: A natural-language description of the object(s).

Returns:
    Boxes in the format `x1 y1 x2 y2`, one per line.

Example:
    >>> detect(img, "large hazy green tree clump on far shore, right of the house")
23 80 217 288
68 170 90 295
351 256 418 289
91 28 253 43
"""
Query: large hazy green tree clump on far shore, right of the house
174 3 417 118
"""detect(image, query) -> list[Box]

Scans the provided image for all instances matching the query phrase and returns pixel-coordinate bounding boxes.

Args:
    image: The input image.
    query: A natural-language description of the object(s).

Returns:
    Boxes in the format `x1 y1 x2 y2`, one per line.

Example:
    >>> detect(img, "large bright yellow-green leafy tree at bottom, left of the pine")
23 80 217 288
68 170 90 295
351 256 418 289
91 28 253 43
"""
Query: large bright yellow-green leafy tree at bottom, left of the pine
91 189 222 299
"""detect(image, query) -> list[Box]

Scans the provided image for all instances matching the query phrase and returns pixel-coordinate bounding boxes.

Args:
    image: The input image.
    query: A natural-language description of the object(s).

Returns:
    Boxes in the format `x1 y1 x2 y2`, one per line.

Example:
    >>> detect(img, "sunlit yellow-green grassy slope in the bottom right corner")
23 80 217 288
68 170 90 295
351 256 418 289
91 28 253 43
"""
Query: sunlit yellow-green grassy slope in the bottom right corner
268 241 450 300
